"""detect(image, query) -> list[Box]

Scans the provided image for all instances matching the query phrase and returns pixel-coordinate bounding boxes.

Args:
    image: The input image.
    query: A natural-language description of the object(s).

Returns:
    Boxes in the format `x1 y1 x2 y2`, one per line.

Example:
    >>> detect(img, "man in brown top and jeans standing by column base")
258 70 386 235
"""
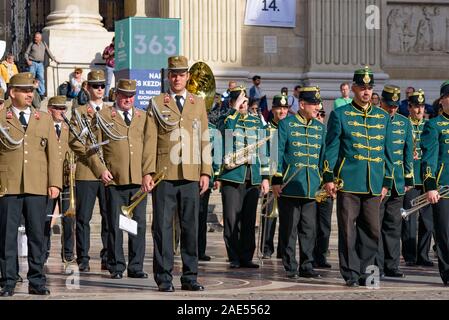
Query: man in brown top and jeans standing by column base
25 32 59 100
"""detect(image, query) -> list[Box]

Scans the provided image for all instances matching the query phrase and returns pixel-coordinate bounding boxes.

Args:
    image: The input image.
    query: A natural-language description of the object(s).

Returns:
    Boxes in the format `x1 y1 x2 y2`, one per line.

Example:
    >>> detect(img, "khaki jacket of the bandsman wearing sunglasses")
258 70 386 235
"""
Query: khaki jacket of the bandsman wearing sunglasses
69 104 104 181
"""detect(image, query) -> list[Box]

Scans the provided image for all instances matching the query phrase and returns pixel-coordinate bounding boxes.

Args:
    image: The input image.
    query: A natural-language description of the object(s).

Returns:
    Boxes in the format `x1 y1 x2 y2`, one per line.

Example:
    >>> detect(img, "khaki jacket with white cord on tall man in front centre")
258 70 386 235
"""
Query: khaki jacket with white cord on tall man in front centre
143 92 212 181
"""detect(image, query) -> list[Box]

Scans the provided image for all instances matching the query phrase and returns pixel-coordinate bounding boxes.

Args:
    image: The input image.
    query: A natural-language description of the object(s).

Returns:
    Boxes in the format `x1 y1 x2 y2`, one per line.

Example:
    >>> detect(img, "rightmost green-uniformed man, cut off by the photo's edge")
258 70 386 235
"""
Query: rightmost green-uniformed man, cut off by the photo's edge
421 80 449 285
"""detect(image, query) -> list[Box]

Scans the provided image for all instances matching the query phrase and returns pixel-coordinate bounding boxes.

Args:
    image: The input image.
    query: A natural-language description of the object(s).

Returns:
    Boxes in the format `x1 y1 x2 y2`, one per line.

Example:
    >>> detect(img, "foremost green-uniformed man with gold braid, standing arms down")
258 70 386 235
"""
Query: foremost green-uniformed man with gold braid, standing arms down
323 67 393 287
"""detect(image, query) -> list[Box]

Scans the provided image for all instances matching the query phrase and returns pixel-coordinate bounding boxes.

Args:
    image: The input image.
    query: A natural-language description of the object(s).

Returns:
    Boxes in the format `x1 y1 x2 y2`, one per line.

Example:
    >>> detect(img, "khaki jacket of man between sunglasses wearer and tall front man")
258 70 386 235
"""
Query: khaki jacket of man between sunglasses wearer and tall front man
89 107 147 185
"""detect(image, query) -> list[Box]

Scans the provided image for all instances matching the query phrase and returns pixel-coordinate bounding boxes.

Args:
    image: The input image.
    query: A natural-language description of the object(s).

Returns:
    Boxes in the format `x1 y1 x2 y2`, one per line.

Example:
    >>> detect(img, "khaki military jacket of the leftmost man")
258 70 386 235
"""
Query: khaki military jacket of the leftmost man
0 107 62 195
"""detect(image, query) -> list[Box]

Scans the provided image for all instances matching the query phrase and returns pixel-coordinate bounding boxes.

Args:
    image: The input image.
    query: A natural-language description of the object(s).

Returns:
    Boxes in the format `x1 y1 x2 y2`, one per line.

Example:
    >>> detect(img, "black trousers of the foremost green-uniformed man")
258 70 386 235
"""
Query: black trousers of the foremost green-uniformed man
337 192 380 281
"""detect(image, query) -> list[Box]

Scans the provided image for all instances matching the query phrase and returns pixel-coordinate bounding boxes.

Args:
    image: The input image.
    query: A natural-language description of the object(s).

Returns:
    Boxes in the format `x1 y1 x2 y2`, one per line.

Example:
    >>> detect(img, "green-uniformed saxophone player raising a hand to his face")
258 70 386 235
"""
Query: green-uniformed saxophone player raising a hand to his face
218 87 269 268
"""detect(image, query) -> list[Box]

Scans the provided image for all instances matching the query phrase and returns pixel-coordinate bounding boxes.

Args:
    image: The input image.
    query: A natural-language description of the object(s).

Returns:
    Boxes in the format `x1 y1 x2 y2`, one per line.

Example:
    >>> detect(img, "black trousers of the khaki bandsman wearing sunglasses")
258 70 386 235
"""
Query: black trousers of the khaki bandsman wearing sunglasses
76 180 109 264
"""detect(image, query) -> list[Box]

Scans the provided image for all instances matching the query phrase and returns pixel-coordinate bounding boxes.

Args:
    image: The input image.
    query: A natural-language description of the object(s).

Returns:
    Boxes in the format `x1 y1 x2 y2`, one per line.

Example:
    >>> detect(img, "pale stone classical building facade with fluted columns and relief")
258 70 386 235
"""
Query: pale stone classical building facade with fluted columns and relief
0 0 449 106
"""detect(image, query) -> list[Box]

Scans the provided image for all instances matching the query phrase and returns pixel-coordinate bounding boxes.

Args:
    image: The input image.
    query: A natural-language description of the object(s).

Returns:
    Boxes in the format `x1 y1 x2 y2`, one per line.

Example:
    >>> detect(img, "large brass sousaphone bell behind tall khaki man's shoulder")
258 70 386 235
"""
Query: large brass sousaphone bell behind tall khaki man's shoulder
186 62 216 112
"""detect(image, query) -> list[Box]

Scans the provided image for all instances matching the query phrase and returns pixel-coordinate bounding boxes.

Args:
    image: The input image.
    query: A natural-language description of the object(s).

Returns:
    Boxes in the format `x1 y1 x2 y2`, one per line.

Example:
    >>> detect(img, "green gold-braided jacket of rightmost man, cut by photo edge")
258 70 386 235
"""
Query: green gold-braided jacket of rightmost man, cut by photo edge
421 113 449 198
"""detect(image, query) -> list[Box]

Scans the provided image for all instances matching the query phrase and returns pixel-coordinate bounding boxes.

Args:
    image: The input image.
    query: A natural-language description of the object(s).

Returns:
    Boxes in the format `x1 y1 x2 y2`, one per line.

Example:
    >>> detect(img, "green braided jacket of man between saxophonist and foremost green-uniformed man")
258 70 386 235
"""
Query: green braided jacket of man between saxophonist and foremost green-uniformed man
273 113 326 199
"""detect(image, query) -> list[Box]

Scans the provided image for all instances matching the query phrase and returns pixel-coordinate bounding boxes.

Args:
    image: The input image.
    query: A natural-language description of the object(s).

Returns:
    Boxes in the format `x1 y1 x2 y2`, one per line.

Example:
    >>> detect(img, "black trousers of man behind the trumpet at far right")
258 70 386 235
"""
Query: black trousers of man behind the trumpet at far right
402 187 433 263
